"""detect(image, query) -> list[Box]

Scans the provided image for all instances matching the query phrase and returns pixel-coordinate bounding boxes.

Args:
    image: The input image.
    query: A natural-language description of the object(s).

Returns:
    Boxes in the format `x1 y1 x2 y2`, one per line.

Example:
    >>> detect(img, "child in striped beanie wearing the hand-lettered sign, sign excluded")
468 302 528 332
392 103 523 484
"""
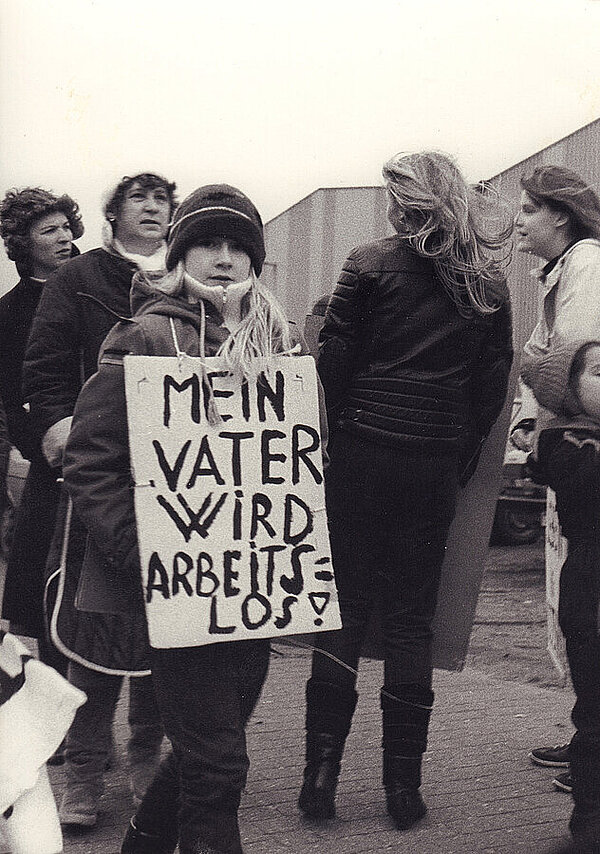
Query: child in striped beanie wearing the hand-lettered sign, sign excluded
63 184 324 854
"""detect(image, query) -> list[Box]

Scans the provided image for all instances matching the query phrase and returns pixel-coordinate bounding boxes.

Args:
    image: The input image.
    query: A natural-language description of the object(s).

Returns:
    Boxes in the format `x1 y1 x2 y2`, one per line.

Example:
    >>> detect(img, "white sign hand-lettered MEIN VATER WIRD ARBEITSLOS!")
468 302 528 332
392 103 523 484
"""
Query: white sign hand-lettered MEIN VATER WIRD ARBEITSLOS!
125 356 341 648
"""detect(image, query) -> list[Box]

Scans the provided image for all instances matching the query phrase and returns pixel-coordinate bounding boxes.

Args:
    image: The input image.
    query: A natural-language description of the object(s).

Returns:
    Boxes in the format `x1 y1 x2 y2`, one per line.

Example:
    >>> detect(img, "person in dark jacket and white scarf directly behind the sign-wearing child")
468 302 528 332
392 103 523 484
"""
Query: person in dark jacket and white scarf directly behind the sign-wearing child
23 172 176 827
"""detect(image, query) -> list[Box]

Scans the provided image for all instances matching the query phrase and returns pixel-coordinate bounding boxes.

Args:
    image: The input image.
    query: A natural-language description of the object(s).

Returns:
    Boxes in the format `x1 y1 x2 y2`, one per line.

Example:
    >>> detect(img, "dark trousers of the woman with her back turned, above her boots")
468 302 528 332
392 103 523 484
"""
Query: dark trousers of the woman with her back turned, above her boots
312 431 458 689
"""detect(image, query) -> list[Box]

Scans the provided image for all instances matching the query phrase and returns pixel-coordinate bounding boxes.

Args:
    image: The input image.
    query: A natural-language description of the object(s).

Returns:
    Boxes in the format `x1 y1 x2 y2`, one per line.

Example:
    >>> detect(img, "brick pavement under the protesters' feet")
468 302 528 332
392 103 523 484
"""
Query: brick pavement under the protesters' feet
43 644 573 854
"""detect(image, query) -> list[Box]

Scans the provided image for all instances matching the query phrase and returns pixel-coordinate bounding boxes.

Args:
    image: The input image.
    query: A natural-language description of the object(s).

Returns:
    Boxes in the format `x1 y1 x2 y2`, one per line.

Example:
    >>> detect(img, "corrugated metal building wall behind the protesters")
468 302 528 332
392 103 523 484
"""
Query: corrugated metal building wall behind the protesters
263 119 600 353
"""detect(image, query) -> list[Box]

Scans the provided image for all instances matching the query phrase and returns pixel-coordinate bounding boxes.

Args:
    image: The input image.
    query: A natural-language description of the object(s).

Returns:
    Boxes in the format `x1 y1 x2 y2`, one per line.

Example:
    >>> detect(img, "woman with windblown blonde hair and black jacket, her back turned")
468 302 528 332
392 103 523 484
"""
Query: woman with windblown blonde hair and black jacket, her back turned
299 151 512 829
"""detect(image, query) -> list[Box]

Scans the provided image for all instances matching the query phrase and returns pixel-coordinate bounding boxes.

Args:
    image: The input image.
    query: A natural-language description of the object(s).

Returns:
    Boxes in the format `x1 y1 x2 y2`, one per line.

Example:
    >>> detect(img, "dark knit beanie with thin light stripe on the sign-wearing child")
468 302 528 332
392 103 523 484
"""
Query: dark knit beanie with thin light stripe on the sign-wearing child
167 184 266 276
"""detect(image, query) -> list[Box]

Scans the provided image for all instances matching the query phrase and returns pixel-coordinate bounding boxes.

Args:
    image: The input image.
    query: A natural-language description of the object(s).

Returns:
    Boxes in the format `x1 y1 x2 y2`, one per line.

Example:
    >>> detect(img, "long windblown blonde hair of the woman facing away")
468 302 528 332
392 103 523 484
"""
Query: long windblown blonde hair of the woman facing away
383 151 513 316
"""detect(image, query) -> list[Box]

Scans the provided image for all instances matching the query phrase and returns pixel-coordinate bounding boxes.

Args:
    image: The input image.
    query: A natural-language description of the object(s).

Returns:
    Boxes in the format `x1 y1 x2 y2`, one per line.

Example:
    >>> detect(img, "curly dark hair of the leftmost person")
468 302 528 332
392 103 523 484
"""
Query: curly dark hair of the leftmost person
0 187 83 275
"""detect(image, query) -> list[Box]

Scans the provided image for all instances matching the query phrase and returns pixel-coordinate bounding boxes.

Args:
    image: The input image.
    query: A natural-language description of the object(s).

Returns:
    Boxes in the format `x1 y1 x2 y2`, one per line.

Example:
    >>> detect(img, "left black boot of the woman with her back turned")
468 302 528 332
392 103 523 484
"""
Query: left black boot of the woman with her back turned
298 679 358 819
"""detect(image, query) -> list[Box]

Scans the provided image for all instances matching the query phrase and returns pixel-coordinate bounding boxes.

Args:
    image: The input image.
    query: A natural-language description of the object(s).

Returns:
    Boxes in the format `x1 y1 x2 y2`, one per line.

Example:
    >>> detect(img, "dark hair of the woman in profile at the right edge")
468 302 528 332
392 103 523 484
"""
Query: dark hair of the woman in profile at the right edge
521 165 600 240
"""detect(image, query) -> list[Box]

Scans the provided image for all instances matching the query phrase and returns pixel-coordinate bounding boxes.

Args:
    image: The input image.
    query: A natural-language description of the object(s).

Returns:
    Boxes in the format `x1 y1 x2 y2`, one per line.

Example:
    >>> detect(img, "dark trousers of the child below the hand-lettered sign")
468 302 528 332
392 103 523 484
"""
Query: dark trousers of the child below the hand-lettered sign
144 640 269 854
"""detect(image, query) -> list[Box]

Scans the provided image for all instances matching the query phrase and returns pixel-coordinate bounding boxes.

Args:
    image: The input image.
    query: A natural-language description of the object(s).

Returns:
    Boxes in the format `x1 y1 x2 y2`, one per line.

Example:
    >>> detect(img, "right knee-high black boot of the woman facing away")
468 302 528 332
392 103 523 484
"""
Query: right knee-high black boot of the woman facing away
381 685 433 830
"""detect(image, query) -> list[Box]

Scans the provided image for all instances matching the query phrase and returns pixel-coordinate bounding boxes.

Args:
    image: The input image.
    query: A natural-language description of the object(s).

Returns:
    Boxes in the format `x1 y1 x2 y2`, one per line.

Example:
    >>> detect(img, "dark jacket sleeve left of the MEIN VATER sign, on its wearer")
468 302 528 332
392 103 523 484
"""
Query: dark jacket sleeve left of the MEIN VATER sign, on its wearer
63 324 143 579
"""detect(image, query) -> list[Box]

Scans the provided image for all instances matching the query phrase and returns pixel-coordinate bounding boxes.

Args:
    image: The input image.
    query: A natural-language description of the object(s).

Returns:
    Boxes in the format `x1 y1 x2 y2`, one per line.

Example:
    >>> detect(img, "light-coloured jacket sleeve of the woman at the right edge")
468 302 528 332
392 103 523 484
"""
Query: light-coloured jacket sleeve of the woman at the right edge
521 245 600 401
